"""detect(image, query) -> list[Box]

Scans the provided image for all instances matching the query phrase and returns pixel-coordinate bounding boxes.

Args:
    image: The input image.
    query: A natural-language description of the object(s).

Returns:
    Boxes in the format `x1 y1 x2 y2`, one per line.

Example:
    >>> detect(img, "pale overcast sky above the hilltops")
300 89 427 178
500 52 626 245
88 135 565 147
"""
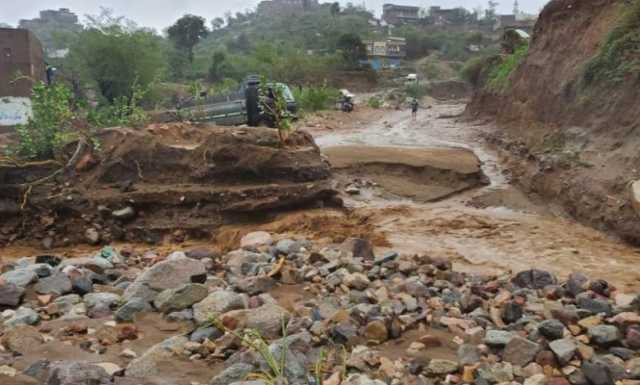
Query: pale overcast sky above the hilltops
0 0 547 30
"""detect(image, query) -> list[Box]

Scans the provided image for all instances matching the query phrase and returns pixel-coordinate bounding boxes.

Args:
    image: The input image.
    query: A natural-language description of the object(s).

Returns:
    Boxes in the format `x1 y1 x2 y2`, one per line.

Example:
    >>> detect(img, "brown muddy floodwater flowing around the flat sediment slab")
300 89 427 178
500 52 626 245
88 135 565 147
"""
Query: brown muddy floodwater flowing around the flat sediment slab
316 104 640 291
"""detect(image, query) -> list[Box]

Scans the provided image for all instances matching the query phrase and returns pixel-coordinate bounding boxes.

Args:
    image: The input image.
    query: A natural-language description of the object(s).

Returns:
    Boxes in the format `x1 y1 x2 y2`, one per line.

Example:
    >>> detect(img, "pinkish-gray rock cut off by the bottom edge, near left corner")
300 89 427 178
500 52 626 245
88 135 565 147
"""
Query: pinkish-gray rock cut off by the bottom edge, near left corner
45 362 113 385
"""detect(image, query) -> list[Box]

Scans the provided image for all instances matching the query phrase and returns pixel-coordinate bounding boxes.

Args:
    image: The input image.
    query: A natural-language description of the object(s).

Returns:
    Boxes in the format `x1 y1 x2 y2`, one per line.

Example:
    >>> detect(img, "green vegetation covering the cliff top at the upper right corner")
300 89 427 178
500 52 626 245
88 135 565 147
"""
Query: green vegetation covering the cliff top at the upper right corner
584 0 640 85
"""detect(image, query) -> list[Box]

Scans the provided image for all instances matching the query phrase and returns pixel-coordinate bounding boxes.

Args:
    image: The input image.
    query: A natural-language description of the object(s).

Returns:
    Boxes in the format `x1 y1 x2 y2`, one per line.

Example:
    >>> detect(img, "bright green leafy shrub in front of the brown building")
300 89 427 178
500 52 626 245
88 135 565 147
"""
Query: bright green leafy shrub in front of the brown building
12 82 74 159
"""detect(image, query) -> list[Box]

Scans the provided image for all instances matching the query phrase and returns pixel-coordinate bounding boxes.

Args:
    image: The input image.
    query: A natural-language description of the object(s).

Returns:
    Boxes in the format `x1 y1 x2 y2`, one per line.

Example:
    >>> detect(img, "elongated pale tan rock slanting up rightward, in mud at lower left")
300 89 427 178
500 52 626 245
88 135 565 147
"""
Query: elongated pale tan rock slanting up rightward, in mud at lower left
126 336 189 378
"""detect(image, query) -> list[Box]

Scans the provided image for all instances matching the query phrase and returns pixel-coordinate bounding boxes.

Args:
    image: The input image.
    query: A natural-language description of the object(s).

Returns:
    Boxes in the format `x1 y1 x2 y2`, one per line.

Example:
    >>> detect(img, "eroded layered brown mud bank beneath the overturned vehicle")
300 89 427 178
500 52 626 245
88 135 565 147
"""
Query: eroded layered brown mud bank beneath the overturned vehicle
0 125 334 245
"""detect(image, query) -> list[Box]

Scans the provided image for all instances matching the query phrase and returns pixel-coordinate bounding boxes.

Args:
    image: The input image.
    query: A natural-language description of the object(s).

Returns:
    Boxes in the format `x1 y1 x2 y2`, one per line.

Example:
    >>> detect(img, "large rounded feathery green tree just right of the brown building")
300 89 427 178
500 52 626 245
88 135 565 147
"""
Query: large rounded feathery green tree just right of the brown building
65 15 166 103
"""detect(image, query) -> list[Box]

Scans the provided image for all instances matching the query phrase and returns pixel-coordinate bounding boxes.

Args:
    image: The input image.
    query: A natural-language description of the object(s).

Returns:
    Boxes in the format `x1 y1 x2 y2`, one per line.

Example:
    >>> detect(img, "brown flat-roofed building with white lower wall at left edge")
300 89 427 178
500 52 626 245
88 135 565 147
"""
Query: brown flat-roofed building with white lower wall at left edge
0 28 46 128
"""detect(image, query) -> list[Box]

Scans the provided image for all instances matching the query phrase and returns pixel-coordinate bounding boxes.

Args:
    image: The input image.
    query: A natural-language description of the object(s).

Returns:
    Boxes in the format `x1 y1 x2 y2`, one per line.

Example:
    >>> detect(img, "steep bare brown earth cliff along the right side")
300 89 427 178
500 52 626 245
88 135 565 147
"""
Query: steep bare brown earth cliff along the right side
467 0 640 243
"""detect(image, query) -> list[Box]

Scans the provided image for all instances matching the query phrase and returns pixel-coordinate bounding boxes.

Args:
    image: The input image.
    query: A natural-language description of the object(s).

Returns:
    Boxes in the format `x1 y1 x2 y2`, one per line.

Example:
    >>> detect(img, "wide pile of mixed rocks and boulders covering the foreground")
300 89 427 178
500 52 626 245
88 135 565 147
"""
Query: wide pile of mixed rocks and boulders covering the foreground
0 233 640 385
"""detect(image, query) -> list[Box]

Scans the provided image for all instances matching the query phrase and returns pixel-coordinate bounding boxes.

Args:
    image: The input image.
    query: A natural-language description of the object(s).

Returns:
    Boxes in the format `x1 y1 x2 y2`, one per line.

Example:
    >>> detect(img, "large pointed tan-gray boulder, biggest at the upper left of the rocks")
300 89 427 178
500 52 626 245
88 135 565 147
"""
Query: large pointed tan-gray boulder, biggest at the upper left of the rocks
135 257 207 291
